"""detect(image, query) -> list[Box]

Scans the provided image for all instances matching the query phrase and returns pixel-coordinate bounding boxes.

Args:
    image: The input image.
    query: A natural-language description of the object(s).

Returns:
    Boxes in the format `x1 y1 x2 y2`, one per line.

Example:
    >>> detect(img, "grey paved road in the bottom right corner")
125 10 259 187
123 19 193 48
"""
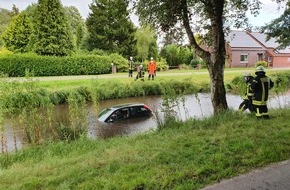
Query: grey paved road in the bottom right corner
202 160 290 190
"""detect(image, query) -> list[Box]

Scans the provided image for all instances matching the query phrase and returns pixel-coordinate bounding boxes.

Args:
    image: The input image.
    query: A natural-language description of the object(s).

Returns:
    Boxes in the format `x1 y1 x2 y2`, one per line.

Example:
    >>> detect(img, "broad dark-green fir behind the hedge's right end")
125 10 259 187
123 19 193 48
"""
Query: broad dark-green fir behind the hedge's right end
86 0 136 57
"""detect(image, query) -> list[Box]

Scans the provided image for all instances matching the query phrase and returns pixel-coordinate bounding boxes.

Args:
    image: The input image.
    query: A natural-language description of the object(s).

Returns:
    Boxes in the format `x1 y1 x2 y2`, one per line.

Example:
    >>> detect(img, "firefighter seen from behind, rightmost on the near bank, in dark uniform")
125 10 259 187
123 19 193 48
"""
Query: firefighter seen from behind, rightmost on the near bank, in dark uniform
251 65 274 119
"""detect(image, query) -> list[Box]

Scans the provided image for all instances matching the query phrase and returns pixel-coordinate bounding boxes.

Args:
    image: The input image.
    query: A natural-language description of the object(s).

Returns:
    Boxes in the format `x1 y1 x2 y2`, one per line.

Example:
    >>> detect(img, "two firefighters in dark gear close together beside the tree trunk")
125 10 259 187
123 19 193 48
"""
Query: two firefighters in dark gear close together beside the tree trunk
239 65 274 119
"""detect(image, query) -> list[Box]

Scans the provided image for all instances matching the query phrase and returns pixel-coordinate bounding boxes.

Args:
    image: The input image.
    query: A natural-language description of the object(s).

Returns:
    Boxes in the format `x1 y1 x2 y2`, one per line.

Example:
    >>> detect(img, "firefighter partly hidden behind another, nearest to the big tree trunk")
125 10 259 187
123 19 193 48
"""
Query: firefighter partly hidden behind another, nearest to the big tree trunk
239 73 254 112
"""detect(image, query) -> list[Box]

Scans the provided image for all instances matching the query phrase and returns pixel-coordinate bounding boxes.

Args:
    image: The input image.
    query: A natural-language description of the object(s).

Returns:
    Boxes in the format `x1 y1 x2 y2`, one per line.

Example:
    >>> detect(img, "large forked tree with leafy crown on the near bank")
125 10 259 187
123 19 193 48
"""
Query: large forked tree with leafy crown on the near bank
133 0 270 114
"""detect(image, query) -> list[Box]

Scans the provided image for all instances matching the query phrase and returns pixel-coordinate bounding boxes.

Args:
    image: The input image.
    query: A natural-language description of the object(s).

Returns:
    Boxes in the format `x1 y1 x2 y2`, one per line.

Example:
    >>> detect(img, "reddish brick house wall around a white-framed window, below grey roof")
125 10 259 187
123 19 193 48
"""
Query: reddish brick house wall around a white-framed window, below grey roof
227 49 266 68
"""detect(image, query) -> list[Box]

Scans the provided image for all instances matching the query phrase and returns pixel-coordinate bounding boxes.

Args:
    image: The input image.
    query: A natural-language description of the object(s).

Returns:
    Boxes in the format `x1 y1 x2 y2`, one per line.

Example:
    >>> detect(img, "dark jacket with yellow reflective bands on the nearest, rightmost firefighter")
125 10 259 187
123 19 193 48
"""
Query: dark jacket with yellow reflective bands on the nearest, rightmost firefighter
251 72 274 106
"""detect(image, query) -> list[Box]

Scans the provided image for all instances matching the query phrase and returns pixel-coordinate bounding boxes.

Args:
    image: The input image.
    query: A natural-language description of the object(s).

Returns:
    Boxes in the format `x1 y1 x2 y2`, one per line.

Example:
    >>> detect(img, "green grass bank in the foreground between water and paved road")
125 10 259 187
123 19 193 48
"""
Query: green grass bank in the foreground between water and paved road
0 109 290 190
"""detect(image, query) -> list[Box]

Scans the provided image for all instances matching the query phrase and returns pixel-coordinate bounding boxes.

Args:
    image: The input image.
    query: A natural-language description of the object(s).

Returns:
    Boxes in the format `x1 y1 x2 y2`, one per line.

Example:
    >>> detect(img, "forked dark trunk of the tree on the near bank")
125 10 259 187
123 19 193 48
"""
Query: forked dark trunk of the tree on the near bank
182 0 228 114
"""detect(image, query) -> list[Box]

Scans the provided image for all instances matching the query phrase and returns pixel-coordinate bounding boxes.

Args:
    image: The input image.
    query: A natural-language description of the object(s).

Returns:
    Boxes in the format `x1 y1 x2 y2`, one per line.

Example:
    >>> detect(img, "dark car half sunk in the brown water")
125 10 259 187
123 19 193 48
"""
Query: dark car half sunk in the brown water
98 103 153 123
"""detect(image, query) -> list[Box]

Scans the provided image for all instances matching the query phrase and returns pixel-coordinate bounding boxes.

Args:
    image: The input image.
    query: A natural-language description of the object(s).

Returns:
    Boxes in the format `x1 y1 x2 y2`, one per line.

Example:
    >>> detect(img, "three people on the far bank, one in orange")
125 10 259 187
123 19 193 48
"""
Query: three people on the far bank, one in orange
128 57 157 81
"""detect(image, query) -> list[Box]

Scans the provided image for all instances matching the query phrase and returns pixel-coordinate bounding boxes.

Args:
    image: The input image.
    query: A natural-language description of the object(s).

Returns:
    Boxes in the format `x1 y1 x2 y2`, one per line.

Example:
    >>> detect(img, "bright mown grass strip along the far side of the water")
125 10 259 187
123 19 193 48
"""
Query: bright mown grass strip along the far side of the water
31 68 288 91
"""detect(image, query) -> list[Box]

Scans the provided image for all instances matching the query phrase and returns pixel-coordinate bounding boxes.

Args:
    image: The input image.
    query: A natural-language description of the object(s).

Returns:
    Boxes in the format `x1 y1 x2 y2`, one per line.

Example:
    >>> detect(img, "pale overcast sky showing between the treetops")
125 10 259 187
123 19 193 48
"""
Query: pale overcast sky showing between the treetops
0 0 283 26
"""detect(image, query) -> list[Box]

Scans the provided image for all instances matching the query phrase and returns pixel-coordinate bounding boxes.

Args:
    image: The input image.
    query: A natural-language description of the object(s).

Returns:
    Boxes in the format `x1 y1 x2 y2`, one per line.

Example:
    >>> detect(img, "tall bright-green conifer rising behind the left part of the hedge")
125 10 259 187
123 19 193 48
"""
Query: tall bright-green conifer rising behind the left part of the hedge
34 0 75 56
